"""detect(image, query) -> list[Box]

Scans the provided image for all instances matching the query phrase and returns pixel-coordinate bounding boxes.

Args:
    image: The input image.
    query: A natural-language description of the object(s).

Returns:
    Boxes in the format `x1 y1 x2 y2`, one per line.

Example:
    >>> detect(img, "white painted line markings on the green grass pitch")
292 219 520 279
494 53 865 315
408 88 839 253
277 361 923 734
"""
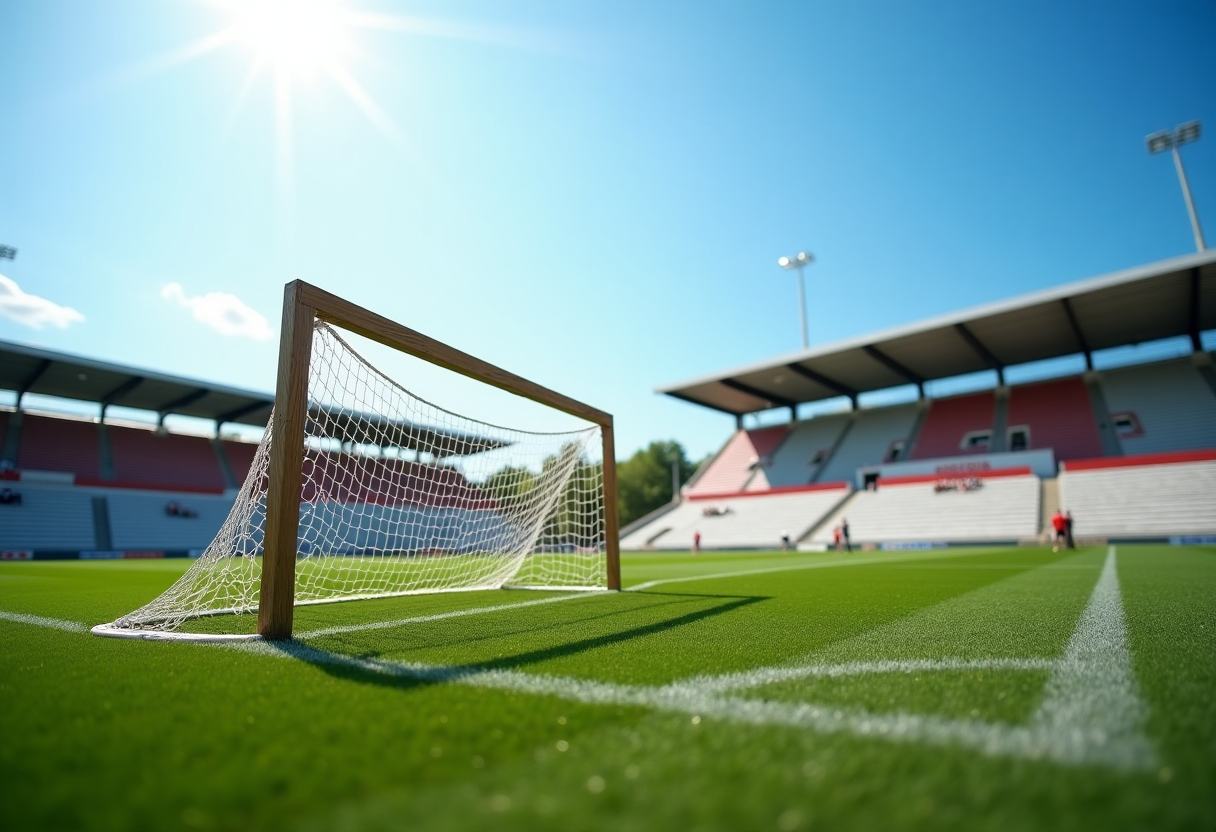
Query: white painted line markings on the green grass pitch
0 546 1158 770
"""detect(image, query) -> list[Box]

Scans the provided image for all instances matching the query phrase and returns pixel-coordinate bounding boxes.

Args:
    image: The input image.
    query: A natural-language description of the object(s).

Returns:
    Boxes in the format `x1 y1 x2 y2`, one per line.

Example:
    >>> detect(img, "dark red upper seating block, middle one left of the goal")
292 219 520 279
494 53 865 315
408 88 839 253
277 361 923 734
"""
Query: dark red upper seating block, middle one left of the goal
107 425 226 491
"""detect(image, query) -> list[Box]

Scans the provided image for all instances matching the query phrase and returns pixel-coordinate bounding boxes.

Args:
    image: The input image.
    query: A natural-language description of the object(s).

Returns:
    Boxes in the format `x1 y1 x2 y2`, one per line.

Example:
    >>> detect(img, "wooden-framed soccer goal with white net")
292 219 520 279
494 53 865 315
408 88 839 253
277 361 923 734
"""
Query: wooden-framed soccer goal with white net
94 281 620 640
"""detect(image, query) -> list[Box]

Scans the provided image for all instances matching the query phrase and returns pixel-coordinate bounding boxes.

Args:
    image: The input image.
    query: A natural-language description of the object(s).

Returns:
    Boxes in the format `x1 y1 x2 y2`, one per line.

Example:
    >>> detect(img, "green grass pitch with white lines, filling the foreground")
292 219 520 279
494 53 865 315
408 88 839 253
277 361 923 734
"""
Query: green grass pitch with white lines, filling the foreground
0 546 1216 832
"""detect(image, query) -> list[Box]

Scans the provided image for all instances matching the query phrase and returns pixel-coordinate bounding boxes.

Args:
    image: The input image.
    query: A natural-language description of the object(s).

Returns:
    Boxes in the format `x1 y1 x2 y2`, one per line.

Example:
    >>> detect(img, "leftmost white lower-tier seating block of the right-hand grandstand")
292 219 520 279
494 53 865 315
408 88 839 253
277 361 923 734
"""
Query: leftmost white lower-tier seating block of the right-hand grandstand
620 483 849 550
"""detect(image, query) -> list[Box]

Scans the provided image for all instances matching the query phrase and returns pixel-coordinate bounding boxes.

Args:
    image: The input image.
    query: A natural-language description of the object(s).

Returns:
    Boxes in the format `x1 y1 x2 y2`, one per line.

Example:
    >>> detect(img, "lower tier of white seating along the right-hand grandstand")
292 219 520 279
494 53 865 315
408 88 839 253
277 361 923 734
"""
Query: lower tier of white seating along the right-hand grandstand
621 451 1216 550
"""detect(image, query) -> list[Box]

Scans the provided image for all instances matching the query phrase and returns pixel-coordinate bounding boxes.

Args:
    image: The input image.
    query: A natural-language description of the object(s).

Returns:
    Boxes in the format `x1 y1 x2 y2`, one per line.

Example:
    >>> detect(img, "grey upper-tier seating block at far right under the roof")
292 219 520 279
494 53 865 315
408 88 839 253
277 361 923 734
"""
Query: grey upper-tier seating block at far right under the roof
1092 358 1216 456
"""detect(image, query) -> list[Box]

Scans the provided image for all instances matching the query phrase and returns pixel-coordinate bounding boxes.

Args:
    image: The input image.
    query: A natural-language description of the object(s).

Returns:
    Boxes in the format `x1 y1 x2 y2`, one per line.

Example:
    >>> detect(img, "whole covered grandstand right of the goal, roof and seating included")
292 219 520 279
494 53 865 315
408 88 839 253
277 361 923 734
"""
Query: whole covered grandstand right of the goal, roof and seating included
621 252 1216 549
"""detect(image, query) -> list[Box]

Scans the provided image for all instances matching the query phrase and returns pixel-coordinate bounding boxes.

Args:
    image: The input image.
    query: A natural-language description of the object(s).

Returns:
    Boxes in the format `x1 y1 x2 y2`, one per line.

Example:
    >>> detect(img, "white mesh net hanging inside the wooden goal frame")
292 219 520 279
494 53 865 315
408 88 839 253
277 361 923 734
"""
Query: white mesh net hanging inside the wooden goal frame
109 322 607 630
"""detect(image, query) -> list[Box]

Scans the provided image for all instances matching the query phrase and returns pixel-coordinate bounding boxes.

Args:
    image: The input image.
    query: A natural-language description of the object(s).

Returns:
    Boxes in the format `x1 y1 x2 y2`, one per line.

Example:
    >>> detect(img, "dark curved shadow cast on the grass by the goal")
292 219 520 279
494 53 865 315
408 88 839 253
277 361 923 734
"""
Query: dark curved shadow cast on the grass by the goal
266 592 767 688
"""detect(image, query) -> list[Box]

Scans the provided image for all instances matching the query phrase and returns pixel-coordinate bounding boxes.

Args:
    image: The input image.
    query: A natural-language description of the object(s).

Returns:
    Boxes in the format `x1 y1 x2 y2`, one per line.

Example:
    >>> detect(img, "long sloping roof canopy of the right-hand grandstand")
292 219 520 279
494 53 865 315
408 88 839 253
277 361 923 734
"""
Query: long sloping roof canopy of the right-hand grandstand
655 251 1216 417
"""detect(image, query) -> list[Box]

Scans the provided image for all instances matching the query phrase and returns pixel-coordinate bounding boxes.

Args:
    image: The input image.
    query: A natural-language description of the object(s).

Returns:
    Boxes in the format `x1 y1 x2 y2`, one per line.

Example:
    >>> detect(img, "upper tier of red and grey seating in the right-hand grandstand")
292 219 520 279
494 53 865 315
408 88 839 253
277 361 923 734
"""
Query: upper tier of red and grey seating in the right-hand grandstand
685 354 1216 497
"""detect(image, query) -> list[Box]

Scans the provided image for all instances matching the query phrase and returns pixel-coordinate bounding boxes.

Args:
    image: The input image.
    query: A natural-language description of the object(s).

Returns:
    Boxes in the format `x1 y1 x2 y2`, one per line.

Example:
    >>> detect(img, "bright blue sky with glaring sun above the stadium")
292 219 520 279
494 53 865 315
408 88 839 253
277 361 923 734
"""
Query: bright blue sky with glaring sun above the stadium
0 0 1216 457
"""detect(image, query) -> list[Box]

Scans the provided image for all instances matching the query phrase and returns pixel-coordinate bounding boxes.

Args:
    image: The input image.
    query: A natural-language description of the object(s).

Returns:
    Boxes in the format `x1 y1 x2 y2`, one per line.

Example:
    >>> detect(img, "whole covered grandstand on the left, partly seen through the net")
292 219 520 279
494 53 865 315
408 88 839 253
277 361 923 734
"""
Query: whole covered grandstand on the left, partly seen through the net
0 342 507 558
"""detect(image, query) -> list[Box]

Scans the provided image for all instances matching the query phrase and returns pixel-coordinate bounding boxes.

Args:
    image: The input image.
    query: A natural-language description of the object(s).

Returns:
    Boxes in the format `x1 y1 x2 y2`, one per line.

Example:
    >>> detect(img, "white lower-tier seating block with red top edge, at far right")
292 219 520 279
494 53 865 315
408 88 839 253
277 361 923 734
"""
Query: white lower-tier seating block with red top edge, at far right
1058 451 1216 539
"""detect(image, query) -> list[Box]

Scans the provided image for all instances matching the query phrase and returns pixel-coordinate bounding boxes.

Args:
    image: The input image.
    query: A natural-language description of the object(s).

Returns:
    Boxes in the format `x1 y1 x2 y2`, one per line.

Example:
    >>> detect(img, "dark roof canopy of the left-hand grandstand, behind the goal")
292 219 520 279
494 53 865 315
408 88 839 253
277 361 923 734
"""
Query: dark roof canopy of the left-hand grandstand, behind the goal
0 341 510 457
